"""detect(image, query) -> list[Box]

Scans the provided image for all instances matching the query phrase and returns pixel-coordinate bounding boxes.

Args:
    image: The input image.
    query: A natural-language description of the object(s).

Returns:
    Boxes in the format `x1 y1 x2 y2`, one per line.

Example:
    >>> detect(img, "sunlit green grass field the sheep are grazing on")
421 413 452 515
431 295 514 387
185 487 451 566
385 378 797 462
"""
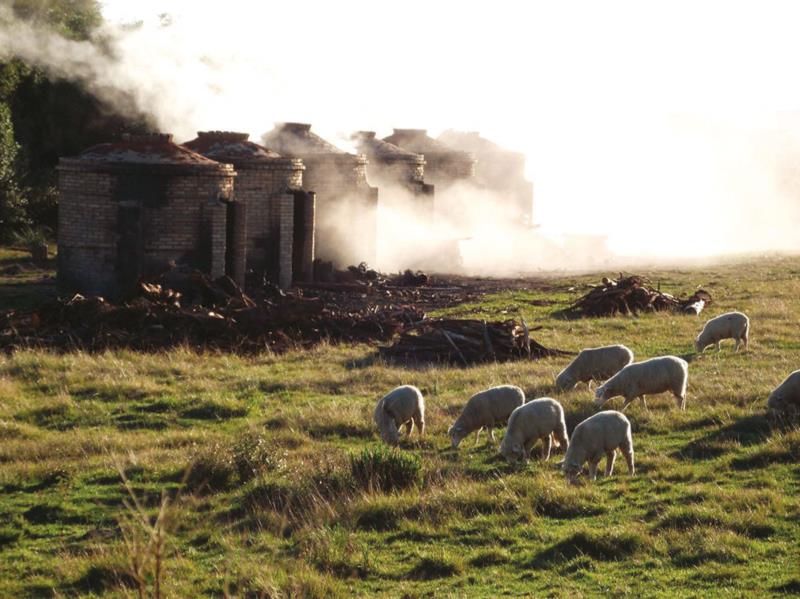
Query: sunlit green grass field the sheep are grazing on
0 257 800 597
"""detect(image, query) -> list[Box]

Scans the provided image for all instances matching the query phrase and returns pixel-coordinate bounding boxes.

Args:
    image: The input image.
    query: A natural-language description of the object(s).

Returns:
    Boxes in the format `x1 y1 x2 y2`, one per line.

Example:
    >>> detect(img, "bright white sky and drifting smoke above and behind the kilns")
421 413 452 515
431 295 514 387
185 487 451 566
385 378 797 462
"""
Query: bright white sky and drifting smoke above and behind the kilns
0 0 800 273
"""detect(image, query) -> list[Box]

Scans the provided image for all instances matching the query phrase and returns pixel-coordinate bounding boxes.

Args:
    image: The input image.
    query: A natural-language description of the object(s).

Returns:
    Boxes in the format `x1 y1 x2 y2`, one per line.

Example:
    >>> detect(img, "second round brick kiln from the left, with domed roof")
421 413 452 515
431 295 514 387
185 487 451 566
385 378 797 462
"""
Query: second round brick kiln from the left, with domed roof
183 131 315 287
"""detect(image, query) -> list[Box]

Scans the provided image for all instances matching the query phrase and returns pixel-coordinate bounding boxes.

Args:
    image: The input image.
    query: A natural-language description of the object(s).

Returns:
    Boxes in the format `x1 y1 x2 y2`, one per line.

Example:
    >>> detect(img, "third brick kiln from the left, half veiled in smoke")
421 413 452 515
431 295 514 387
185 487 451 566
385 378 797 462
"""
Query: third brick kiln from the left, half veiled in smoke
261 123 378 266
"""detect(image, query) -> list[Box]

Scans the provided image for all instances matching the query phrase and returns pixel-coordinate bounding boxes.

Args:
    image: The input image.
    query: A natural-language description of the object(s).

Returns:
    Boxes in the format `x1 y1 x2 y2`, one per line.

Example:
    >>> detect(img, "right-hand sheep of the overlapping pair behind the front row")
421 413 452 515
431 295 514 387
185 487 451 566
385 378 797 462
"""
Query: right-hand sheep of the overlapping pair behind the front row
594 356 689 410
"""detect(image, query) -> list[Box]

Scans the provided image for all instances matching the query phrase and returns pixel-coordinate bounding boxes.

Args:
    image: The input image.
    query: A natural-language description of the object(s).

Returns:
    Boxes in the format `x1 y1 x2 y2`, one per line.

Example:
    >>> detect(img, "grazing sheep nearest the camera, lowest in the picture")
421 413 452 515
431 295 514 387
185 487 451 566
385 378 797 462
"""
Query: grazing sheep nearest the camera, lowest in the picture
561 410 635 484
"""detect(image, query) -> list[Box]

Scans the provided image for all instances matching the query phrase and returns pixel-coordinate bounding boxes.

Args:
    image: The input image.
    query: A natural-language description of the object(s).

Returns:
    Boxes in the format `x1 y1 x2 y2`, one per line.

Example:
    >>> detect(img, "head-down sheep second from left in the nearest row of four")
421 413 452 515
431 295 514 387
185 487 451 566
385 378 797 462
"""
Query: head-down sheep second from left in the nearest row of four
447 385 525 449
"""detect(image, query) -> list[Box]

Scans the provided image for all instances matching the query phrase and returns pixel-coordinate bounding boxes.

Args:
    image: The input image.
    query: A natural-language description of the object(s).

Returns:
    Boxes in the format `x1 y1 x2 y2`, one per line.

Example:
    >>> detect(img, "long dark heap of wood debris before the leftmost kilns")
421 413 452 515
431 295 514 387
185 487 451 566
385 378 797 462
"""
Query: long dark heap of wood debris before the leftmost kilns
0 270 425 353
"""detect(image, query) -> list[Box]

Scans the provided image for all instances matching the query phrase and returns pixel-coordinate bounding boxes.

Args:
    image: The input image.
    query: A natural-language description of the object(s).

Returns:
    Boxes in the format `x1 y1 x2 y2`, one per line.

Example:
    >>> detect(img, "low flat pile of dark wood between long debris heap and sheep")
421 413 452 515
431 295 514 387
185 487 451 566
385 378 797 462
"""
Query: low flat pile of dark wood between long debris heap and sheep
381 318 569 366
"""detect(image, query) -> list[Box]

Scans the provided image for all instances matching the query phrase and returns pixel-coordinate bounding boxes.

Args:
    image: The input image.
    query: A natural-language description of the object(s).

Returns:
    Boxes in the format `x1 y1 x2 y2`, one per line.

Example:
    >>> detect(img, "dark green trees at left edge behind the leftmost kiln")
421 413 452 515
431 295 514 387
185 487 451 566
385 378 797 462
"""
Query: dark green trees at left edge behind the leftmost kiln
0 0 146 242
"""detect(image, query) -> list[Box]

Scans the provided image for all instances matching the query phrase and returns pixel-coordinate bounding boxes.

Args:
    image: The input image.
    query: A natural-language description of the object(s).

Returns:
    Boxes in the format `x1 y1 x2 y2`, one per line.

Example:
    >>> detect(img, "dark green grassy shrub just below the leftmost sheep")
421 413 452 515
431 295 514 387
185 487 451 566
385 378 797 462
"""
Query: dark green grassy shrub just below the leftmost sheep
350 445 422 493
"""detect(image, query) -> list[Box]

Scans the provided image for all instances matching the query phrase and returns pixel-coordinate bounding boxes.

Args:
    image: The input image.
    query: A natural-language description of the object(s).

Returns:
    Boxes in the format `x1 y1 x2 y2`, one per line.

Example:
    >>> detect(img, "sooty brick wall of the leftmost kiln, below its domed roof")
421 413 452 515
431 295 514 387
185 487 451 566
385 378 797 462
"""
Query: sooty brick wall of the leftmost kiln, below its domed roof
58 161 234 296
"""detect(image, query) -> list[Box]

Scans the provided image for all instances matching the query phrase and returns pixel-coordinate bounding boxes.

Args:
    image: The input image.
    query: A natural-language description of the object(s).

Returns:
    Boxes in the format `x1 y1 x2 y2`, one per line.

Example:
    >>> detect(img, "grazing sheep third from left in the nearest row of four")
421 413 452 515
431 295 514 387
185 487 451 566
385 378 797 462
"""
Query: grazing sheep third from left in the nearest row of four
500 397 569 461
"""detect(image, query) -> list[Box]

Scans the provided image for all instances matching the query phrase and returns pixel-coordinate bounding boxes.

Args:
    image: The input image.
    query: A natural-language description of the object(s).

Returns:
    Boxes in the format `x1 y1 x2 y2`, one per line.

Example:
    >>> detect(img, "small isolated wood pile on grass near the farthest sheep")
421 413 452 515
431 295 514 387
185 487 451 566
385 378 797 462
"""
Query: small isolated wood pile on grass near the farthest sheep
565 273 712 317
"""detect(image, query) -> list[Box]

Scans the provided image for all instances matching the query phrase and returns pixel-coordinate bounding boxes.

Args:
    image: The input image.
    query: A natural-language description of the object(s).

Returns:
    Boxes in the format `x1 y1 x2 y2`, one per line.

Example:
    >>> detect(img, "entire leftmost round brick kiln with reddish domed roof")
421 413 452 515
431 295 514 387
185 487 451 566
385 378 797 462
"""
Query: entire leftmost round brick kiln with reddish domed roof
58 134 238 296
